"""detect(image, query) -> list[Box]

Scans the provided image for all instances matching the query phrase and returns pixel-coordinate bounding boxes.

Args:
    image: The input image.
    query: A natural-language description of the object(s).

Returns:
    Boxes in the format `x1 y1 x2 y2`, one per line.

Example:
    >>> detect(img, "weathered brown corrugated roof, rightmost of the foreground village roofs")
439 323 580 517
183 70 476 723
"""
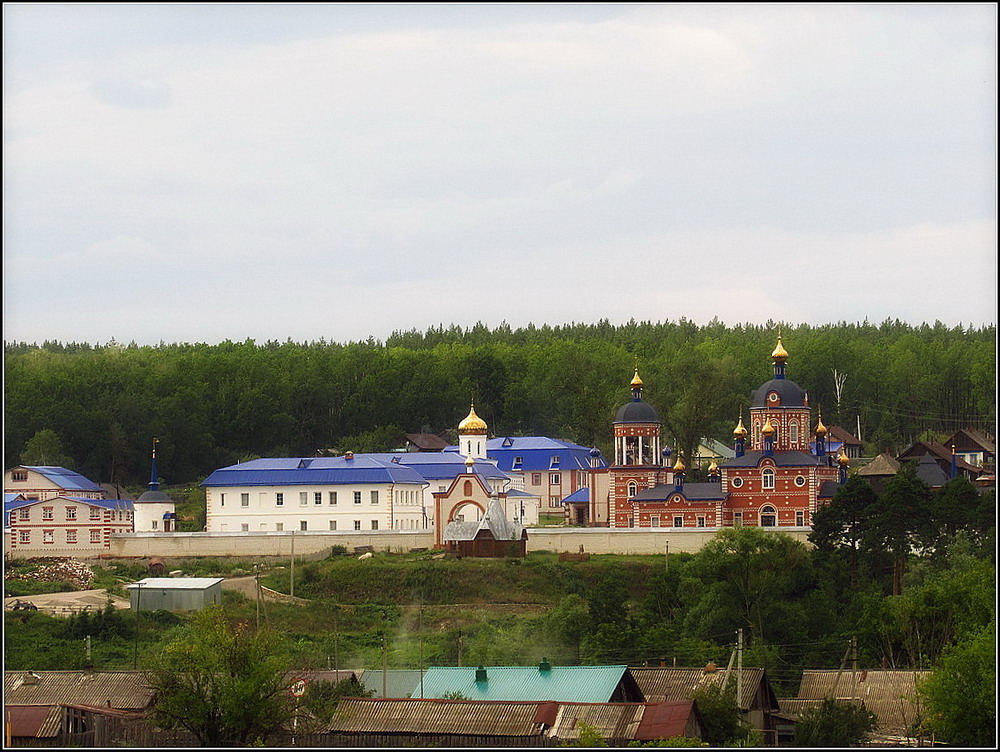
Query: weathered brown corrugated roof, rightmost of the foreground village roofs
783 669 931 733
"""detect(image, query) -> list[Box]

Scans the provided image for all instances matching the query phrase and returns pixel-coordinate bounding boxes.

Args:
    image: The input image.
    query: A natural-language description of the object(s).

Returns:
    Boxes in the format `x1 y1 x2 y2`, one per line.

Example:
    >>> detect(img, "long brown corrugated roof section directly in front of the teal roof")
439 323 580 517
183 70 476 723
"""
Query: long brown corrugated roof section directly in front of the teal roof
327 698 541 737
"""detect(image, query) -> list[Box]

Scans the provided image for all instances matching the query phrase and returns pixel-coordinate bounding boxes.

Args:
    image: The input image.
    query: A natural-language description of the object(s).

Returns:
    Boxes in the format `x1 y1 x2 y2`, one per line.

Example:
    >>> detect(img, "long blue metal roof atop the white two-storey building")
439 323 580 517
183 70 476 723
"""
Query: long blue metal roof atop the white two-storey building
201 454 428 487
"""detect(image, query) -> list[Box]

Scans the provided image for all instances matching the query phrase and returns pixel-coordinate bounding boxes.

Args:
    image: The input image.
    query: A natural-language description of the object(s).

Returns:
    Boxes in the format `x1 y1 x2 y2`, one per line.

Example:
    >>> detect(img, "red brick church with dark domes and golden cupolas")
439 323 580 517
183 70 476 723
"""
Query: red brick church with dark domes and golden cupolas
609 337 848 528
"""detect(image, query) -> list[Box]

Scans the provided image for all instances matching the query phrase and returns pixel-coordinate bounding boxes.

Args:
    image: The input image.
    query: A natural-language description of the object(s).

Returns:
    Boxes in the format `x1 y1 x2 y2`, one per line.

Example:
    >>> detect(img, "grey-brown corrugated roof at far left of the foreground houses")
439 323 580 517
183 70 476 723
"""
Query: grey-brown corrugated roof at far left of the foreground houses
3 671 153 710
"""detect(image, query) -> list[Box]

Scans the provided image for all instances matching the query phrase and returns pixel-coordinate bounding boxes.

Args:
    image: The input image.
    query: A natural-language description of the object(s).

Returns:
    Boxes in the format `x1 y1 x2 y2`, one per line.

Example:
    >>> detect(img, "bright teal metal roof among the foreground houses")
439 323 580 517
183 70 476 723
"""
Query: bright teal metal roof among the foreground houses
424 666 628 702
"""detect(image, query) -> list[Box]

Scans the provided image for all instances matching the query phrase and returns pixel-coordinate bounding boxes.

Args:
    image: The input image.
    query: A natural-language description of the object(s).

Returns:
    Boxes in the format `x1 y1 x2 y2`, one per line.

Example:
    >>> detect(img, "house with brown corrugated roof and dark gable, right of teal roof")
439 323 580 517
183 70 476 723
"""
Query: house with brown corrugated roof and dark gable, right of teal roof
629 663 779 745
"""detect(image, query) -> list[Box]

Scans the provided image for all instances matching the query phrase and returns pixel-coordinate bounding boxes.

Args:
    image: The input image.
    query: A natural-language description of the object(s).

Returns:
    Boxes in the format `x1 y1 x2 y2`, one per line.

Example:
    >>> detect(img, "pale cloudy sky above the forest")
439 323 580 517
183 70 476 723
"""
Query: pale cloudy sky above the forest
3 3 997 345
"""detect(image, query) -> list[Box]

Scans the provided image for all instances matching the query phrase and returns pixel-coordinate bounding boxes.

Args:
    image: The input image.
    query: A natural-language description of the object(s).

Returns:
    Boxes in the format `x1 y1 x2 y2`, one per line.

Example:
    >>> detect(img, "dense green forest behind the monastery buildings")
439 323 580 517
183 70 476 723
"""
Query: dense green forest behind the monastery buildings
4 319 996 485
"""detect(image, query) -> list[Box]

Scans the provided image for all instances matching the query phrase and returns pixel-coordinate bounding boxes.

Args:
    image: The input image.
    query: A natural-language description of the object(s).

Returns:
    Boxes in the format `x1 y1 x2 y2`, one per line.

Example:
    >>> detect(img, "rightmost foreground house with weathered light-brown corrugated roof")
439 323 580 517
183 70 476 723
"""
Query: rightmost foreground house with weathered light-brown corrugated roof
780 669 931 746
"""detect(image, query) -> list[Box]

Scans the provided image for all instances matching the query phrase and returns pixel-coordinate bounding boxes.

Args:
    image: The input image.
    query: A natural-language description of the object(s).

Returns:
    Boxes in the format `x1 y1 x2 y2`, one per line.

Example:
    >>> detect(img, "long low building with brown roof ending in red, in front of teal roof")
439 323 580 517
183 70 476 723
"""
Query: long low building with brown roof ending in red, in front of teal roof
327 698 702 747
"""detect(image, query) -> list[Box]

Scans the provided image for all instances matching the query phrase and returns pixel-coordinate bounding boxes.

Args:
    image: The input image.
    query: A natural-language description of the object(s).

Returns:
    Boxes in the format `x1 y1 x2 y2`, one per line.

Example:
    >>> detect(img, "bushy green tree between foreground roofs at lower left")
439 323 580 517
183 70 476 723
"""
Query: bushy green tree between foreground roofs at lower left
149 606 291 747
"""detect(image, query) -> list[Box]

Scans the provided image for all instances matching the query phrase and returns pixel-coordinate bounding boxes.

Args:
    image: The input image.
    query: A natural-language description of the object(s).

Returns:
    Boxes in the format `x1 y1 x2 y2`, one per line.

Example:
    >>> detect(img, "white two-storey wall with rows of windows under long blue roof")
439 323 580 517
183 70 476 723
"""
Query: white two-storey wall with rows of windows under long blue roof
205 483 432 533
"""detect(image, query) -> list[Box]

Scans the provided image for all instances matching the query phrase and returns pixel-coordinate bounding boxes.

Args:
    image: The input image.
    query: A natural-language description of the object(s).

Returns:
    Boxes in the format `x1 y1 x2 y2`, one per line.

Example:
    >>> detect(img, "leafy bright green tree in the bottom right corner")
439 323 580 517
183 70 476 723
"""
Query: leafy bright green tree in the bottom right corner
918 622 997 748
